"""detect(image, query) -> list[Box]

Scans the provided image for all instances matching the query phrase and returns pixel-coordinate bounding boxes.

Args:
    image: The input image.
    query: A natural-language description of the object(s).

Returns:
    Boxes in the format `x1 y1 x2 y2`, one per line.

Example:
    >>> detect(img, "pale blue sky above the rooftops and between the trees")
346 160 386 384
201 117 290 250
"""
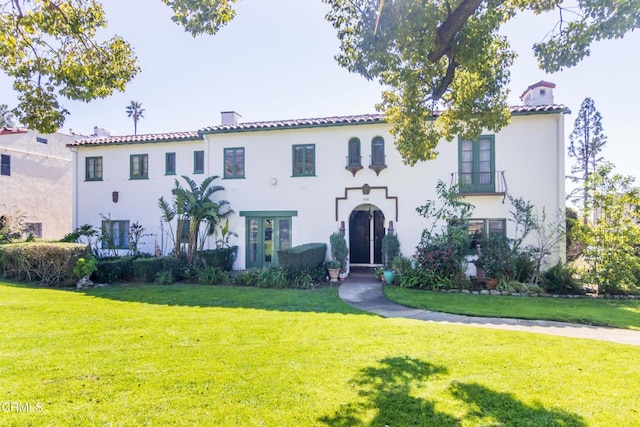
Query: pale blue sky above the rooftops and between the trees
0 0 640 176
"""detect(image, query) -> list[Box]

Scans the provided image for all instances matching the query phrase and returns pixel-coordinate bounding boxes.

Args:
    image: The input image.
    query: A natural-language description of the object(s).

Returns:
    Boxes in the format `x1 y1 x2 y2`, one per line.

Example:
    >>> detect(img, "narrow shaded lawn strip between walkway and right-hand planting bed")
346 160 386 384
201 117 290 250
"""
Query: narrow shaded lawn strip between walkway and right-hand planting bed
384 286 640 330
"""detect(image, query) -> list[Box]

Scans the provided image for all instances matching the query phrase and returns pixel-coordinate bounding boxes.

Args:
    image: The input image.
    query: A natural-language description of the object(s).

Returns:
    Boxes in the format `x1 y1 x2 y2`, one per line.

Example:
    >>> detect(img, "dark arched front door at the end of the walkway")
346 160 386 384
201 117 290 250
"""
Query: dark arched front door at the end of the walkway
349 204 384 265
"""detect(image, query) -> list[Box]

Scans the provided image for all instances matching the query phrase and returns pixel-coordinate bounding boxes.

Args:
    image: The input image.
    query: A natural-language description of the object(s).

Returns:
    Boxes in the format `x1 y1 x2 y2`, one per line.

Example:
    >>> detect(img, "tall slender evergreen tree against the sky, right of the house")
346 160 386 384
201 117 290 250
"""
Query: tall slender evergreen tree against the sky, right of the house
569 98 607 224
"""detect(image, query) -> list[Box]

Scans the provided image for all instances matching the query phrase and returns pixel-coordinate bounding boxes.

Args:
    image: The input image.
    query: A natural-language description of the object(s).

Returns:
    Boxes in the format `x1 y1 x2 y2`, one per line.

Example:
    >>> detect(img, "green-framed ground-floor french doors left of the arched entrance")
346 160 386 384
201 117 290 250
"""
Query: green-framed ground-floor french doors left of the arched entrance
245 215 291 268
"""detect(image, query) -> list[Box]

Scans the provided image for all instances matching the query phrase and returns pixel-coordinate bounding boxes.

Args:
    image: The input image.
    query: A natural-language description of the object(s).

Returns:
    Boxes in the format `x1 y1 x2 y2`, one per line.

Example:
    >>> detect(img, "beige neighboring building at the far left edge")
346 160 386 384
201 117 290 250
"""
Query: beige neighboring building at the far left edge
0 128 77 240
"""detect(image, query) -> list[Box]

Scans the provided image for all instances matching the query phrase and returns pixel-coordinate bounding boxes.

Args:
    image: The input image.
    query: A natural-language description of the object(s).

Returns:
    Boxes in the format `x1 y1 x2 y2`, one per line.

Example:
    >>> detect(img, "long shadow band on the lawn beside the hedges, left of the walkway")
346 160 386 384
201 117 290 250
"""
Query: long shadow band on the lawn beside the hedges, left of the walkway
0 281 376 316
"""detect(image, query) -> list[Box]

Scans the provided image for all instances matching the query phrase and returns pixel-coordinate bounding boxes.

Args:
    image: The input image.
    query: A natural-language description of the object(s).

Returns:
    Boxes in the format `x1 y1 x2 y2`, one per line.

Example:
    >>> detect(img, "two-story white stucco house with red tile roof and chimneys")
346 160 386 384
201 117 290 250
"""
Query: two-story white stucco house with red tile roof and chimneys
69 82 569 269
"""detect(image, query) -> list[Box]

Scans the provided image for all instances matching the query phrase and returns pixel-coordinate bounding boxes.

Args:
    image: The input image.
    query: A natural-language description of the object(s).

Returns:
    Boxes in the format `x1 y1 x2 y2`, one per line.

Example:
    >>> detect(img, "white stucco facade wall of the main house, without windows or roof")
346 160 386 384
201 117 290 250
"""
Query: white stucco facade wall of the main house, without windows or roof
75 114 565 268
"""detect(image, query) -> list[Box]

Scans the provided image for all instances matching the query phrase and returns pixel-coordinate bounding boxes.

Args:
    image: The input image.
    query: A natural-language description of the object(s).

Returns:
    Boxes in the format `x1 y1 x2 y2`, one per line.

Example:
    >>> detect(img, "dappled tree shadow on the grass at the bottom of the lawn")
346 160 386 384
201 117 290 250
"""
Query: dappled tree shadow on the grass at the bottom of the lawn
319 357 586 427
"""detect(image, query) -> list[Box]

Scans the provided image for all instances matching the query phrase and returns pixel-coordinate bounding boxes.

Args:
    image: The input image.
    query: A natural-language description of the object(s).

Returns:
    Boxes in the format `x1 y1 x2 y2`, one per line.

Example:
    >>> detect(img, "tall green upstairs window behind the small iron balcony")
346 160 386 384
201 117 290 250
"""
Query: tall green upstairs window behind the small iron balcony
458 135 495 193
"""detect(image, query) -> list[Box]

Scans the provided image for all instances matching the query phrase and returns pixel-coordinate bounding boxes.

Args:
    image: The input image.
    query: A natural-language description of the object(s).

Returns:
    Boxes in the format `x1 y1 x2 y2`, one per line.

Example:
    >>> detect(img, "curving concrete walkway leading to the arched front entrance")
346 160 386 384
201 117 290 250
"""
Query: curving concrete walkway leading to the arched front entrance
338 271 640 346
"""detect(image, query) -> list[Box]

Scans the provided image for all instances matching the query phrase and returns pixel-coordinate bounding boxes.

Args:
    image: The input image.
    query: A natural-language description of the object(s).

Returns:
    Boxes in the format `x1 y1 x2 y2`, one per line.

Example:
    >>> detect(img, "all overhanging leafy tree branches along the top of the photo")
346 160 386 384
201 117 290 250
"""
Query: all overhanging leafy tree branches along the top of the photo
0 0 640 164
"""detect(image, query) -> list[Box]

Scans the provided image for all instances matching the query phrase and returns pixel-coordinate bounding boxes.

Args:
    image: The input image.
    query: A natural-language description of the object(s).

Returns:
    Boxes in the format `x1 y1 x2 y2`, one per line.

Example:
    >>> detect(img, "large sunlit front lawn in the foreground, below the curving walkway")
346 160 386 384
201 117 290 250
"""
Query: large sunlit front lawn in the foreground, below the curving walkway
0 282 640 427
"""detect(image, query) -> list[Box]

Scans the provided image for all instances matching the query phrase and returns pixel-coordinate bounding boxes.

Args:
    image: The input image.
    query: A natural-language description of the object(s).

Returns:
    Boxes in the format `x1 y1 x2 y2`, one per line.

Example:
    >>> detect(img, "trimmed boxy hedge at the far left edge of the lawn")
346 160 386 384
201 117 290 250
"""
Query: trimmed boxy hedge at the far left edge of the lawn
0 242 91 286
